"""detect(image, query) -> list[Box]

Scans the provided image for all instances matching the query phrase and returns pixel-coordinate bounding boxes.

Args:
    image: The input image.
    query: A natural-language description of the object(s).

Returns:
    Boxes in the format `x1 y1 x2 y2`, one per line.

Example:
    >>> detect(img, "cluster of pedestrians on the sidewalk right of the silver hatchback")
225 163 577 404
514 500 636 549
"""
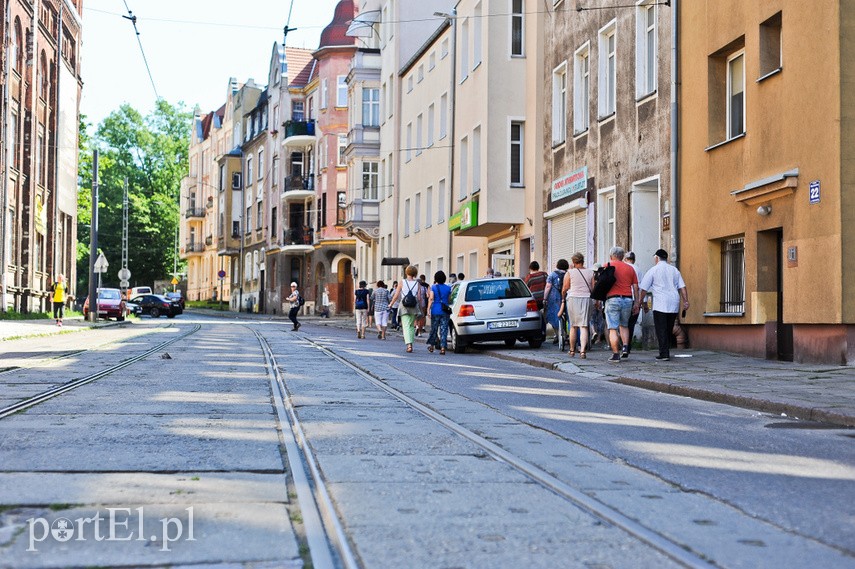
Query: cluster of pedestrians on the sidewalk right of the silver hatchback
540 247 689 363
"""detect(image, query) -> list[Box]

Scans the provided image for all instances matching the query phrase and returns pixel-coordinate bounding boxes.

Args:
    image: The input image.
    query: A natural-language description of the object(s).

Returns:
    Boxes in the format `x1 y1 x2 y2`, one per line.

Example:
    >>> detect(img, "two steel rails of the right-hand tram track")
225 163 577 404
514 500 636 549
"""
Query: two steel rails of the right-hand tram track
280 337 716 569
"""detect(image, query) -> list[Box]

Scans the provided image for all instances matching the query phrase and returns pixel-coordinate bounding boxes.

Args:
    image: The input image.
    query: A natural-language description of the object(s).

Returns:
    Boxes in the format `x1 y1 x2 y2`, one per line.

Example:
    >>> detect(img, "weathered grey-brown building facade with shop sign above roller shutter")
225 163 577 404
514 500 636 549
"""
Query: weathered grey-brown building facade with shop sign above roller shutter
543 0 677 278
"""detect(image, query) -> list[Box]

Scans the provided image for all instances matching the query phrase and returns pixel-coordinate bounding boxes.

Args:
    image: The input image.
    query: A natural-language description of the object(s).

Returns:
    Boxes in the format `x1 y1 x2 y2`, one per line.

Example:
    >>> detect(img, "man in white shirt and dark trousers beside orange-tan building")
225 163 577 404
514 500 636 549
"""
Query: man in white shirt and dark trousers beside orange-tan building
637 249 689 361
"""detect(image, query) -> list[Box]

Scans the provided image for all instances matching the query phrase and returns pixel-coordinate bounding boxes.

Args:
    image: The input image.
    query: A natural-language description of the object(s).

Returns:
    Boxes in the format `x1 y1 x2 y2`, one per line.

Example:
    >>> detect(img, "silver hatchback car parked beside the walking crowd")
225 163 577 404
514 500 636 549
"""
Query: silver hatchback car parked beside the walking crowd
448 277 543 354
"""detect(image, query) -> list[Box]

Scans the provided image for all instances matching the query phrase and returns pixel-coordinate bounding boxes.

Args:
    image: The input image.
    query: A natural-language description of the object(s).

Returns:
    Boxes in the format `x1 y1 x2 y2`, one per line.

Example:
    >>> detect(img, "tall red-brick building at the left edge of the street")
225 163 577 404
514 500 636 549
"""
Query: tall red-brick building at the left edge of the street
0 0 86 312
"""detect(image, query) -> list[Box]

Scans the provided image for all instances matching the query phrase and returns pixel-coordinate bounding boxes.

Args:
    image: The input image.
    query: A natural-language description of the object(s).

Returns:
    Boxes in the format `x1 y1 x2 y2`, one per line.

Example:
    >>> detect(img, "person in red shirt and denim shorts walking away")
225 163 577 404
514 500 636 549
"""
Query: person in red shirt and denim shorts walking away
606 247 638 363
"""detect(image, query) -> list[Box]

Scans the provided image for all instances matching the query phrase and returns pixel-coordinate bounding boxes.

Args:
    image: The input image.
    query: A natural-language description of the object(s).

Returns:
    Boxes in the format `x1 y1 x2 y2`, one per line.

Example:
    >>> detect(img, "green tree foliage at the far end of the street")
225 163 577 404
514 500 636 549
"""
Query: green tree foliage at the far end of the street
77 99 192 290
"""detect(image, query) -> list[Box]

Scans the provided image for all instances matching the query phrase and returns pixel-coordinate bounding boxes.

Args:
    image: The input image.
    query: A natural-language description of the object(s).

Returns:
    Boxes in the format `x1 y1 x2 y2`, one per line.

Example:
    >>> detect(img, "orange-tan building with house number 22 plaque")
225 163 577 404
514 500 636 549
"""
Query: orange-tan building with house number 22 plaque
679 0 855 364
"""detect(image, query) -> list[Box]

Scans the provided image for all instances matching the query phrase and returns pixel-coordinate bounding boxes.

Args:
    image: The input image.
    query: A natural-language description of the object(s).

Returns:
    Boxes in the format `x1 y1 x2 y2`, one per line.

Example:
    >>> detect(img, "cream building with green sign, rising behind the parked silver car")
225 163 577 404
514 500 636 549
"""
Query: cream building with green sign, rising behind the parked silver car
448 0 545 276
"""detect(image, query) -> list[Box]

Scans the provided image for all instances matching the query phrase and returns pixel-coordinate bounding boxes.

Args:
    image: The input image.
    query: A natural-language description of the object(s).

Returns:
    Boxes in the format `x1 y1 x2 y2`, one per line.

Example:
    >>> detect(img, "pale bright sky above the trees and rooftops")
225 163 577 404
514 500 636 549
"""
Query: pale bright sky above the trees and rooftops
80 0 338 126
